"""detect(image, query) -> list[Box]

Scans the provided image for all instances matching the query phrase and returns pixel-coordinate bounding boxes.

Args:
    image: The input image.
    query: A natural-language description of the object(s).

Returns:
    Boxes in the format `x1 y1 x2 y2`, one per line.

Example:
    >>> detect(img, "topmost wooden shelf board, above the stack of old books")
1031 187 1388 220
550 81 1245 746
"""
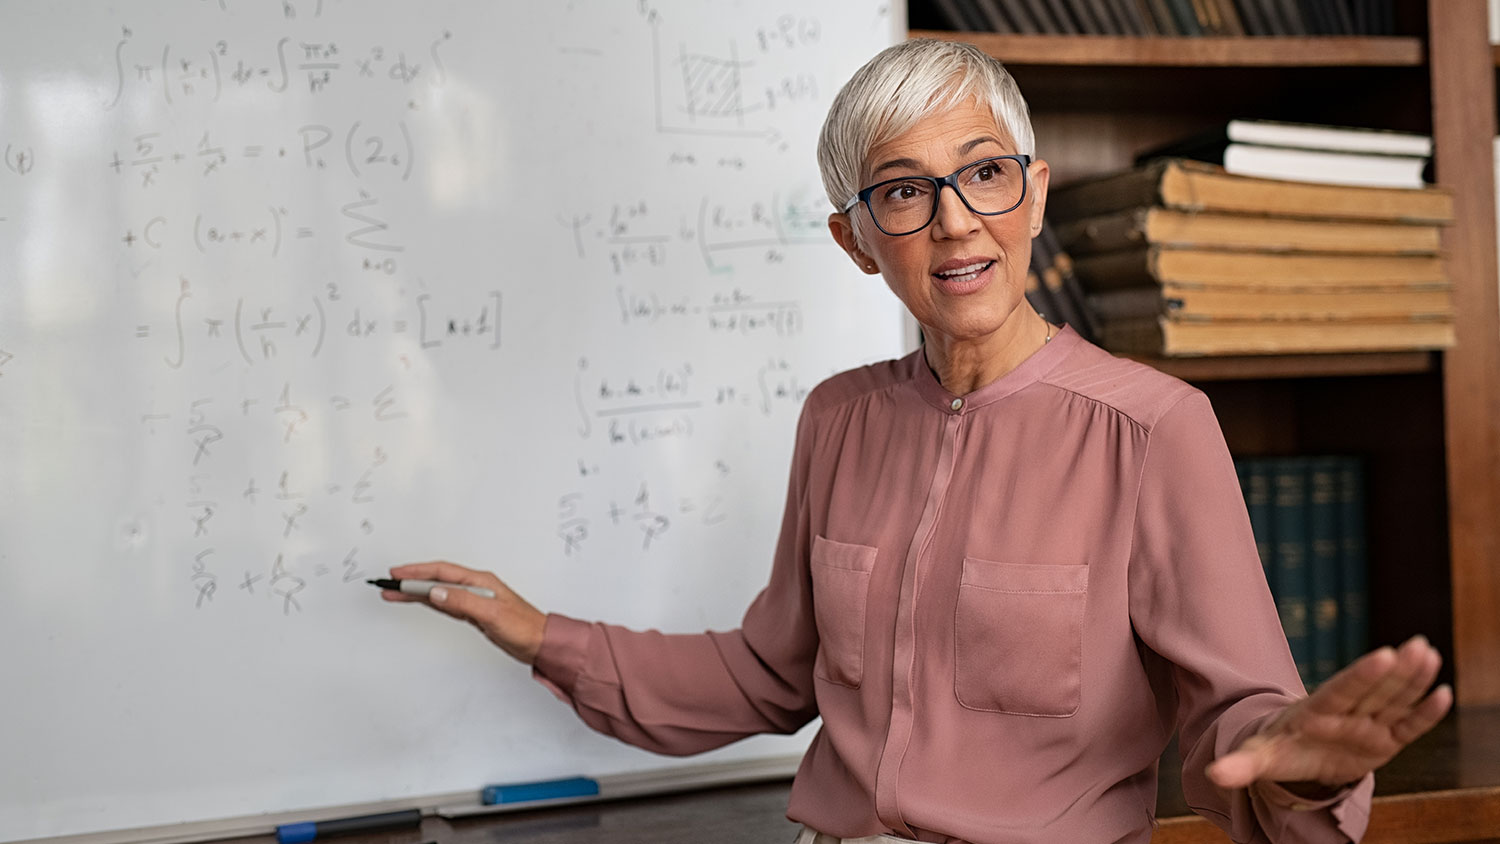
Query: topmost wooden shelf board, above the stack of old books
911 30 1427 67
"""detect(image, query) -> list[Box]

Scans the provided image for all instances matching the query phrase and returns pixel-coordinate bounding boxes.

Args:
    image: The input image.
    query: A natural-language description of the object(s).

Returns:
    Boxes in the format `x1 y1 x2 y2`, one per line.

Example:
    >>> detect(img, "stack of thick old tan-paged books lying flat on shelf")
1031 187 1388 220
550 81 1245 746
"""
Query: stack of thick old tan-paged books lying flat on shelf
1047 152 1454 357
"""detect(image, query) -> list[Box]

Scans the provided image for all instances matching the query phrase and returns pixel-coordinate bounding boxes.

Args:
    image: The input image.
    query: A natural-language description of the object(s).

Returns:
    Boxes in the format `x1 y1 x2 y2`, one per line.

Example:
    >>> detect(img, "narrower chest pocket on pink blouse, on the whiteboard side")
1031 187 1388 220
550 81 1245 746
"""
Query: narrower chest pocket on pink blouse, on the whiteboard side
812 537 875 688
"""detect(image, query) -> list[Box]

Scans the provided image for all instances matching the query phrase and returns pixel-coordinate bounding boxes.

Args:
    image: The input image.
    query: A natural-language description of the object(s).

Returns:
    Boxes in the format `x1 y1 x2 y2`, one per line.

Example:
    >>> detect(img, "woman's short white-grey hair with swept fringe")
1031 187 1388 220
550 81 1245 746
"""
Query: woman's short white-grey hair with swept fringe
818 37 1037 211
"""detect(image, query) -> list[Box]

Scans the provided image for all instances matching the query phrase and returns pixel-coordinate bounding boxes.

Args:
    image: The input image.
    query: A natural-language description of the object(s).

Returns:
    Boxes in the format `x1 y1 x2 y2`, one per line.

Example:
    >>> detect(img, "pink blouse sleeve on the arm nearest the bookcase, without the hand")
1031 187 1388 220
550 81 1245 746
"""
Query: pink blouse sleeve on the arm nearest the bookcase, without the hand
1130 391 1374 843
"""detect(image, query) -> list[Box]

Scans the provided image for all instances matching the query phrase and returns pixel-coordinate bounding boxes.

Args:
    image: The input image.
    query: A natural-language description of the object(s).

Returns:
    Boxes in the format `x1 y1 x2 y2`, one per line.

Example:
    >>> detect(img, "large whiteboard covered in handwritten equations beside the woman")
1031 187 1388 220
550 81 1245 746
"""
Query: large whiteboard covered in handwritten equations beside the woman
0 0 902 841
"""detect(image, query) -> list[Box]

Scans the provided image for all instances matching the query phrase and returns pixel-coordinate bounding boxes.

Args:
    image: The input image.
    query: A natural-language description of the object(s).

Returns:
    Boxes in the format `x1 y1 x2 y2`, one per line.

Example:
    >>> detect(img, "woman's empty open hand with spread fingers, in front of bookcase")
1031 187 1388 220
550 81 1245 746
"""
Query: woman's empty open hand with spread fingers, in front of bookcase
1208 636 1454 793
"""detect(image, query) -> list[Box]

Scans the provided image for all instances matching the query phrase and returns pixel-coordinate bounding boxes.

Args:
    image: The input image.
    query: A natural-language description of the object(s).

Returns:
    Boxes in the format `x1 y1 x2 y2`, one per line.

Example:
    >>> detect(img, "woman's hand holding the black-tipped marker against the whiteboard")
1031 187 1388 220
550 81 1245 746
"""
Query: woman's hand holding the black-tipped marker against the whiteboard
381 561 548 666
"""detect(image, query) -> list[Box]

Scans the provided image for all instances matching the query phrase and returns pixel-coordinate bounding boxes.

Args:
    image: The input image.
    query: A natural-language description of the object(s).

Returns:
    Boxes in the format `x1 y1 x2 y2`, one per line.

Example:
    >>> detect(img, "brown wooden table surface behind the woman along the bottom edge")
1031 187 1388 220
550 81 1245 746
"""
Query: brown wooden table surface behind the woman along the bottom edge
214 708 1500 844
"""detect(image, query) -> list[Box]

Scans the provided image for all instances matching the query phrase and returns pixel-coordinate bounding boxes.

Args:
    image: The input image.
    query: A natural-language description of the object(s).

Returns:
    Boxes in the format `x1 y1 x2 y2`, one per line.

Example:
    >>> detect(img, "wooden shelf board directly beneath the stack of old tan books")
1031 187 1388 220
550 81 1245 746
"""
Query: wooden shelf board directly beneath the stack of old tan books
1127 351 1437 381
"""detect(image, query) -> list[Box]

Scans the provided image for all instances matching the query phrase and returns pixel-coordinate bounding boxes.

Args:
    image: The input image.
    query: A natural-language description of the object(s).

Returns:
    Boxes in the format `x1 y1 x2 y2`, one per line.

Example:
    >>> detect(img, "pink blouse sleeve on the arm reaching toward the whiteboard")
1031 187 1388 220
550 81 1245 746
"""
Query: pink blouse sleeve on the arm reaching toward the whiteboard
533 401 818 756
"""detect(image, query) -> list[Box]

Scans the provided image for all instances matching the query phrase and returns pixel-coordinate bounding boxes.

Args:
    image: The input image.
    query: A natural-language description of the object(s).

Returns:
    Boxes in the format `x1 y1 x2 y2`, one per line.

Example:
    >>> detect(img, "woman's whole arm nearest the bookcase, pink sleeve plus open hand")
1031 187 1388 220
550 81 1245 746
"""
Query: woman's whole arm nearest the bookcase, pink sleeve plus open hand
1130 391 1451 841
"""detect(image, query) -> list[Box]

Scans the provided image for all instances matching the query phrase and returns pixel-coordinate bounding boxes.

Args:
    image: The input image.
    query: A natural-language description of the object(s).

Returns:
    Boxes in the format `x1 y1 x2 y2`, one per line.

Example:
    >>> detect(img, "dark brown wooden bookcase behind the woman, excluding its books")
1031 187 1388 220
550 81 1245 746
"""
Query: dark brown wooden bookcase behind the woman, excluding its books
911 0 1500 706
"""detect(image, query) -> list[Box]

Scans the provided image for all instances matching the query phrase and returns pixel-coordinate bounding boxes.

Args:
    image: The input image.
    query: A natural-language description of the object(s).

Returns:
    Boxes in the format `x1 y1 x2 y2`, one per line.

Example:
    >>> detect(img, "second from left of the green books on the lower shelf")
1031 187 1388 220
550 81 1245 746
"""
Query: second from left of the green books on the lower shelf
1271 457 1313 685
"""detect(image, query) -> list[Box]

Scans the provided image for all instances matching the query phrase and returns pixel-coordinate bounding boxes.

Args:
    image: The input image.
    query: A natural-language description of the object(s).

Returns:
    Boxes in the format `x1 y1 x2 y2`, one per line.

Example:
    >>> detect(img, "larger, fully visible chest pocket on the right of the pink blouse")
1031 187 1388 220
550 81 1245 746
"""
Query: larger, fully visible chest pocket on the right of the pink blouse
954 558 1089 718
